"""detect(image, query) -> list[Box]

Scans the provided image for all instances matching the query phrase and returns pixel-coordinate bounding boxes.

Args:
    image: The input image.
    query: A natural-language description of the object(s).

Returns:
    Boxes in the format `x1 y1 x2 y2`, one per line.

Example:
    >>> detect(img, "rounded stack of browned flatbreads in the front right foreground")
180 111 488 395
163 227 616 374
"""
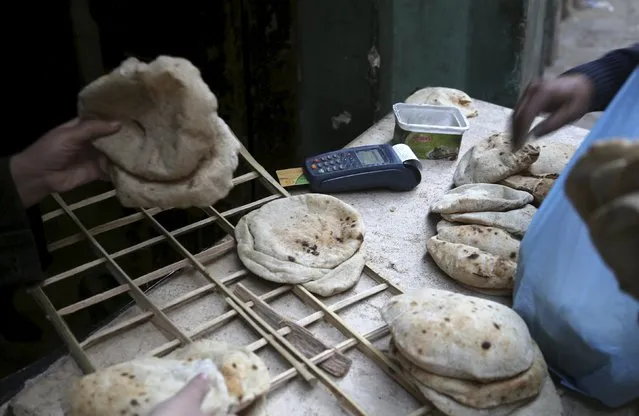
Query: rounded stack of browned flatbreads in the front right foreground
382 289 562 416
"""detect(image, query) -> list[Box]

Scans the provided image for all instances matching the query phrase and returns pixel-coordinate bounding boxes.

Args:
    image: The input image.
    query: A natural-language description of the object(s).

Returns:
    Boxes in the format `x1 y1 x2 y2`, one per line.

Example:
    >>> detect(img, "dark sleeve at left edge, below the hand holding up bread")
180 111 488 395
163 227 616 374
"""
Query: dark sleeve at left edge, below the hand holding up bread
0 159 43 290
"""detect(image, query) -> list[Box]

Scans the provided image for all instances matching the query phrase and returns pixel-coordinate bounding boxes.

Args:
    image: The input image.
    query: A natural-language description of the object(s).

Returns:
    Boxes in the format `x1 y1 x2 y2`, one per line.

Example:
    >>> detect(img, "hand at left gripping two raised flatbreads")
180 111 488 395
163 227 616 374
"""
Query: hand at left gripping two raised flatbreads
10 119 120 207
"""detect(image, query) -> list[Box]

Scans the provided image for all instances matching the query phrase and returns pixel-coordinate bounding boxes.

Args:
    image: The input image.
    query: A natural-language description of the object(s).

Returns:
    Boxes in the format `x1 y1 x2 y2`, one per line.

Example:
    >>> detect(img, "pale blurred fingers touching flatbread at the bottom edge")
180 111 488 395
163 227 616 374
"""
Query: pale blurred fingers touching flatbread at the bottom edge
150 374 211 416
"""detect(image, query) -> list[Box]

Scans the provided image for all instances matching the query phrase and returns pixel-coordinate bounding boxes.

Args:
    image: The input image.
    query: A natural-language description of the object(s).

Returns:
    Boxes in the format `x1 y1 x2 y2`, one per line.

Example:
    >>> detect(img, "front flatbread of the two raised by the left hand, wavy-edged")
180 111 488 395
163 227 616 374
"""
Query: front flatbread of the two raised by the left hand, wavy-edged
78 56 217 181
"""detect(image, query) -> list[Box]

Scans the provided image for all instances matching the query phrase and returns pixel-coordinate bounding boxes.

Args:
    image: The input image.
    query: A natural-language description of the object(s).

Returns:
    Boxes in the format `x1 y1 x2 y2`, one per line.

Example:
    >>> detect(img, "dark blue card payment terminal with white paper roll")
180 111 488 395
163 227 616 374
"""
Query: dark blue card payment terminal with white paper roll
304 144 422 193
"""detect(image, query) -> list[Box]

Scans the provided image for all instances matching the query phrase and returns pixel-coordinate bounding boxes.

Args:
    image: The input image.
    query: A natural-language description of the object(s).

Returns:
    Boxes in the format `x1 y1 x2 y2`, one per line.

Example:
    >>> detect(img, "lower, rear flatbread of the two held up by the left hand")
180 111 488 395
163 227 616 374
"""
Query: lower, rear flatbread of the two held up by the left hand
110 116 240 208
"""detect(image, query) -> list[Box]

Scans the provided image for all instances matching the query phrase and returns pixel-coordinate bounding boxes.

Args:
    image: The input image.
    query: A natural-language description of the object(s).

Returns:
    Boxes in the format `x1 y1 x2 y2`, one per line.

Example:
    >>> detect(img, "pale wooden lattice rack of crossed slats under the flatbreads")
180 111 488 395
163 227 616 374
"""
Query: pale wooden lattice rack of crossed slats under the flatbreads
30 146 432 416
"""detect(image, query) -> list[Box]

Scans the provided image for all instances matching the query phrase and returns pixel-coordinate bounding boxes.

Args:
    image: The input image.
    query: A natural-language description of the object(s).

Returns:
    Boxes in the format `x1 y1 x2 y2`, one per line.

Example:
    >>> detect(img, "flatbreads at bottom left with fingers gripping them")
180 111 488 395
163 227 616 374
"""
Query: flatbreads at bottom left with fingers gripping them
68 340 270 416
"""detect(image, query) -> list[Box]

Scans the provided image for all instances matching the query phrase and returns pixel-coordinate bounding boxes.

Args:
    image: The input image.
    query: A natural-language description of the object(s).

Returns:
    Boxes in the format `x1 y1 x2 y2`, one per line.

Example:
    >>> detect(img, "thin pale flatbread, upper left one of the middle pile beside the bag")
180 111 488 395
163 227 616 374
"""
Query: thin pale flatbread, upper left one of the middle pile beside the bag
430 183 533 214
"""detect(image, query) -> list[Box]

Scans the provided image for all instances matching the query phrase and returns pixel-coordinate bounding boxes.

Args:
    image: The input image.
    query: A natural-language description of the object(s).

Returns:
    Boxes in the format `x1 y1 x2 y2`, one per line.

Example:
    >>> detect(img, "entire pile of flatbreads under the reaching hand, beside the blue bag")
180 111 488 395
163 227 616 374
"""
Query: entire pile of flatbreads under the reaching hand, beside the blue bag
427 133 575 296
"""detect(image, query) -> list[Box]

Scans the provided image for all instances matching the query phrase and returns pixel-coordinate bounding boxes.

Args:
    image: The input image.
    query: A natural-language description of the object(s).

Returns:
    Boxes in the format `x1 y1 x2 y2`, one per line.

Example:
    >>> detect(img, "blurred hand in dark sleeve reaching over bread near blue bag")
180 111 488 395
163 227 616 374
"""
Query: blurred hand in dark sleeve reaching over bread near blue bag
511 74 594 147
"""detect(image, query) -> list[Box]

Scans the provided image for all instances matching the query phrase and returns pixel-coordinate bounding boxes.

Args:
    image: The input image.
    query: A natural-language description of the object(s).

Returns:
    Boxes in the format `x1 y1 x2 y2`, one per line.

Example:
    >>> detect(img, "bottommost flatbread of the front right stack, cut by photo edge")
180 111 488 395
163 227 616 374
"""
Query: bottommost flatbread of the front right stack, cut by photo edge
417 373 563 416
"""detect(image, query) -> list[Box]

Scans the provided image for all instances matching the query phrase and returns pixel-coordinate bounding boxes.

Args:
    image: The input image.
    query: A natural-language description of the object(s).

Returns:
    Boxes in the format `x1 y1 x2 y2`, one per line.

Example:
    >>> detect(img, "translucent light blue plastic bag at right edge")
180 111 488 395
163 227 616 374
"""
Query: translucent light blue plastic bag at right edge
514 69 639 407
